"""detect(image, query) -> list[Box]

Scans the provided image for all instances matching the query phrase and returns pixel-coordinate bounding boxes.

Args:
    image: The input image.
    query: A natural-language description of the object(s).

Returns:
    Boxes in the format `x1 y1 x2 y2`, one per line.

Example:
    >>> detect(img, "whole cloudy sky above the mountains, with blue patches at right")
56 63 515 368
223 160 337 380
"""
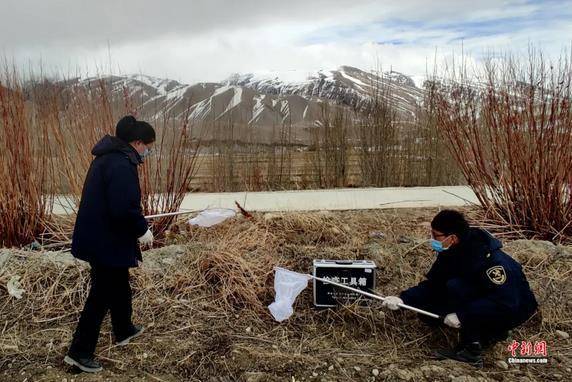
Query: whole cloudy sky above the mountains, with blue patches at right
0 0 572 83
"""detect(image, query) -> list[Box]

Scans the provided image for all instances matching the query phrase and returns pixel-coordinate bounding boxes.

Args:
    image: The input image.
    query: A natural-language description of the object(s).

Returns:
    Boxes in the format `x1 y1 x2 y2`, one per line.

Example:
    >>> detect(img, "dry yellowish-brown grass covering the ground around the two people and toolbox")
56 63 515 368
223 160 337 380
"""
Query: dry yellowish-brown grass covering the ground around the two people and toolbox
0 210 572 381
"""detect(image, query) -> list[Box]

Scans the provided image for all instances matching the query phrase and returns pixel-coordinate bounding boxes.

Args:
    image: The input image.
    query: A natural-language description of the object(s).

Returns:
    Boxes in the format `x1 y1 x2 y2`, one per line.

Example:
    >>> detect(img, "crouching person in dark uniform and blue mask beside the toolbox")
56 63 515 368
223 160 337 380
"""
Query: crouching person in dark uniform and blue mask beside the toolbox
383 210 537 367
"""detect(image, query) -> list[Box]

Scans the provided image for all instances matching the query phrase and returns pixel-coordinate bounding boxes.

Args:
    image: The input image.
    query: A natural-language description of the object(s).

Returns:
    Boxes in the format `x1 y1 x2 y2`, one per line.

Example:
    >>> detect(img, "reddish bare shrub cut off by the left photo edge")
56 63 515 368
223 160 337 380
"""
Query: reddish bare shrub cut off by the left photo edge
0 63 55 247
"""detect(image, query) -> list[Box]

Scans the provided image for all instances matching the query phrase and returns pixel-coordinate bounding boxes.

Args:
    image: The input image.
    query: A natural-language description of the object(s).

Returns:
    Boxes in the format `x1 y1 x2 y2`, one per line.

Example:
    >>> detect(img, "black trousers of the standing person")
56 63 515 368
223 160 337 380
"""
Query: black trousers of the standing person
69 264 133 358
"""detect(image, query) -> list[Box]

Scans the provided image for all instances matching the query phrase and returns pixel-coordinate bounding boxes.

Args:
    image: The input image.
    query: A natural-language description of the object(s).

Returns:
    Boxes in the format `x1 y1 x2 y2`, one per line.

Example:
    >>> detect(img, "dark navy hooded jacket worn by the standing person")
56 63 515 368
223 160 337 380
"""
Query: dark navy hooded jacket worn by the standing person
72 135 148 267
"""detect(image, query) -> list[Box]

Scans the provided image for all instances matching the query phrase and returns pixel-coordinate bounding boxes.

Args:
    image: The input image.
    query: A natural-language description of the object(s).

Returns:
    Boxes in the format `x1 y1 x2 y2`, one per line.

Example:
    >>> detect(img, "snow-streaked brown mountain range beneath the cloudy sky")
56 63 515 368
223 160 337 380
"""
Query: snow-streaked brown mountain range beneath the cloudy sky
67 66 423 143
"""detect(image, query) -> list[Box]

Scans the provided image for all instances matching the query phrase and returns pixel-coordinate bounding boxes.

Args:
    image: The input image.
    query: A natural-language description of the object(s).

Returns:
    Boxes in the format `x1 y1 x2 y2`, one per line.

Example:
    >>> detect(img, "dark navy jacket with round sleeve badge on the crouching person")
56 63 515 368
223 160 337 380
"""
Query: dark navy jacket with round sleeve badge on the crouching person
400 228 537 327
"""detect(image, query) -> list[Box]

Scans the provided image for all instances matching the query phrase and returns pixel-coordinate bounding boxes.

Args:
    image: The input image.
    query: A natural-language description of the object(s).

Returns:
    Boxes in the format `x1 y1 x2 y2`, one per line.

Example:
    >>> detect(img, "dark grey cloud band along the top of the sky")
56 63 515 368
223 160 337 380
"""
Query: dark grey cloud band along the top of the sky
0 0 527 49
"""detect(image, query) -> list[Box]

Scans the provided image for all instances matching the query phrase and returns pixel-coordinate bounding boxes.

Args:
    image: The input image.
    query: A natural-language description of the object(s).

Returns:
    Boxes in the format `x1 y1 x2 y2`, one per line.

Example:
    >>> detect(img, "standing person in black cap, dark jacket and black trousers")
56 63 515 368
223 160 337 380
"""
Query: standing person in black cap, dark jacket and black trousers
64 116 155 372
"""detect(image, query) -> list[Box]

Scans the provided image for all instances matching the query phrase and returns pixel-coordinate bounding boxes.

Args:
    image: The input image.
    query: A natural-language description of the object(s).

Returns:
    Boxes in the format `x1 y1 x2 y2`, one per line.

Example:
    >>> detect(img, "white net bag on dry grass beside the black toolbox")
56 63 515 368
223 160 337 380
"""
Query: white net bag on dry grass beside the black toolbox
268 267 310 322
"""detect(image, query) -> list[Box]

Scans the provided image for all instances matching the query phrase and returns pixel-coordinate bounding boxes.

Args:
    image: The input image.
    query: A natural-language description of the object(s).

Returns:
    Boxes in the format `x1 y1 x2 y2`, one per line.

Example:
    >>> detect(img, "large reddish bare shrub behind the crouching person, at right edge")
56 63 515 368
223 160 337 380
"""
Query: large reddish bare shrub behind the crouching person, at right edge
431 49 572 240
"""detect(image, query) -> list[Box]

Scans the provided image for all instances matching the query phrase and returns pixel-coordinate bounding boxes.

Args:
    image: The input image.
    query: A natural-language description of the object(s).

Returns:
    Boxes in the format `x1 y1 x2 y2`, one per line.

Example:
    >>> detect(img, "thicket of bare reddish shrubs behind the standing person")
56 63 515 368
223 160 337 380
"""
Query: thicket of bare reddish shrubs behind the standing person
0 65 201 246
